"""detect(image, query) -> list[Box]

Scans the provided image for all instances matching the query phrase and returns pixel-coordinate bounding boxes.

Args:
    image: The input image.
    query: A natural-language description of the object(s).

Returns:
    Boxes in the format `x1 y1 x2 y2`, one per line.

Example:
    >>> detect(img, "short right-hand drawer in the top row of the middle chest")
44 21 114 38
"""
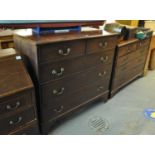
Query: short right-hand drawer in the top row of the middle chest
86 36 117 53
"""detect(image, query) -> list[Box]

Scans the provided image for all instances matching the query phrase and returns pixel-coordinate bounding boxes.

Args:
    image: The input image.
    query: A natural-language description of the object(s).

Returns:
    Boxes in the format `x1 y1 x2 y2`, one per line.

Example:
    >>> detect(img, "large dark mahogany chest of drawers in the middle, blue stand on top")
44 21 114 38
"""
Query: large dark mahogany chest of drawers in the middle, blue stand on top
14 34 117 134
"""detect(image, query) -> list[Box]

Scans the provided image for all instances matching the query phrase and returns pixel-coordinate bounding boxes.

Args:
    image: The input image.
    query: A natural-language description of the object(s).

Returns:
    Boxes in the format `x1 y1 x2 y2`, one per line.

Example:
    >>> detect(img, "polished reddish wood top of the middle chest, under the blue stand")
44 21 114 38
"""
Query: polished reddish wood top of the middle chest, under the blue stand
15 28 118 44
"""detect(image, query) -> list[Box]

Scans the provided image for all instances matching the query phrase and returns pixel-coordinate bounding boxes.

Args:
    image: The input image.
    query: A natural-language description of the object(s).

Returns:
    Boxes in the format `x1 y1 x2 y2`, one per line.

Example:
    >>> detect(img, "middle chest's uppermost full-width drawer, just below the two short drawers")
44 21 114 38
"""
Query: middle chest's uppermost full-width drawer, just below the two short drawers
39 51 114 83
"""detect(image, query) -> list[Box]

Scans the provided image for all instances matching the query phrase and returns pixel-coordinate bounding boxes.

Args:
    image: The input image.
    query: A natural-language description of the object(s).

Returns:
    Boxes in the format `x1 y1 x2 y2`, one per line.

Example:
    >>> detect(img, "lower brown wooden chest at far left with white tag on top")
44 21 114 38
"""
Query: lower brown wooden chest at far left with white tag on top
0 49 39 135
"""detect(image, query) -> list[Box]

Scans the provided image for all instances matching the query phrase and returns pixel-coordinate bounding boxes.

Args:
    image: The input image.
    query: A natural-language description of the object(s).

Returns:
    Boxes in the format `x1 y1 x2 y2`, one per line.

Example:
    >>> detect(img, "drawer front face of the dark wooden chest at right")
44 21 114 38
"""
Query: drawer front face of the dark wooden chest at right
110 38 150 96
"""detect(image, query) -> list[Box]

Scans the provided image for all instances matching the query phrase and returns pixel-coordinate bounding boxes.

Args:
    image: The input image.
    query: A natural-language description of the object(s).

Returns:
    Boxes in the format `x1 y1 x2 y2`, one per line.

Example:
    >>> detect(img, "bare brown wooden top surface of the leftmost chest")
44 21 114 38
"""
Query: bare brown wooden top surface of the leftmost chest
0 49 33 99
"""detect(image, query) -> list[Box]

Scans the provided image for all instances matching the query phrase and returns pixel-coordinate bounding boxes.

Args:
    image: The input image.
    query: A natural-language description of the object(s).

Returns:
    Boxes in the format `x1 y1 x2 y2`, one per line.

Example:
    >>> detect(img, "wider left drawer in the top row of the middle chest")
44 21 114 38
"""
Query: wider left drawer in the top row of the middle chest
39 40 85 63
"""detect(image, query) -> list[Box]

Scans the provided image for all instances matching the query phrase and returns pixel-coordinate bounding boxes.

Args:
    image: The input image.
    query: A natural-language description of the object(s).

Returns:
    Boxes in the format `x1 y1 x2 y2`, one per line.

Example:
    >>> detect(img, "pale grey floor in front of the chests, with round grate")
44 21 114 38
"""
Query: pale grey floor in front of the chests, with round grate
50 71 155 135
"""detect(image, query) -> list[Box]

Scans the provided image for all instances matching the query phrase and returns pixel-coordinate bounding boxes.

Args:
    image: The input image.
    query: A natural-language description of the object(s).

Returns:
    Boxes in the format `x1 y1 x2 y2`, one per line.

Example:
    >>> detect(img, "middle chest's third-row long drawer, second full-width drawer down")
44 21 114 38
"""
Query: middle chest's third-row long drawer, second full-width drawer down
41 66 111 105
